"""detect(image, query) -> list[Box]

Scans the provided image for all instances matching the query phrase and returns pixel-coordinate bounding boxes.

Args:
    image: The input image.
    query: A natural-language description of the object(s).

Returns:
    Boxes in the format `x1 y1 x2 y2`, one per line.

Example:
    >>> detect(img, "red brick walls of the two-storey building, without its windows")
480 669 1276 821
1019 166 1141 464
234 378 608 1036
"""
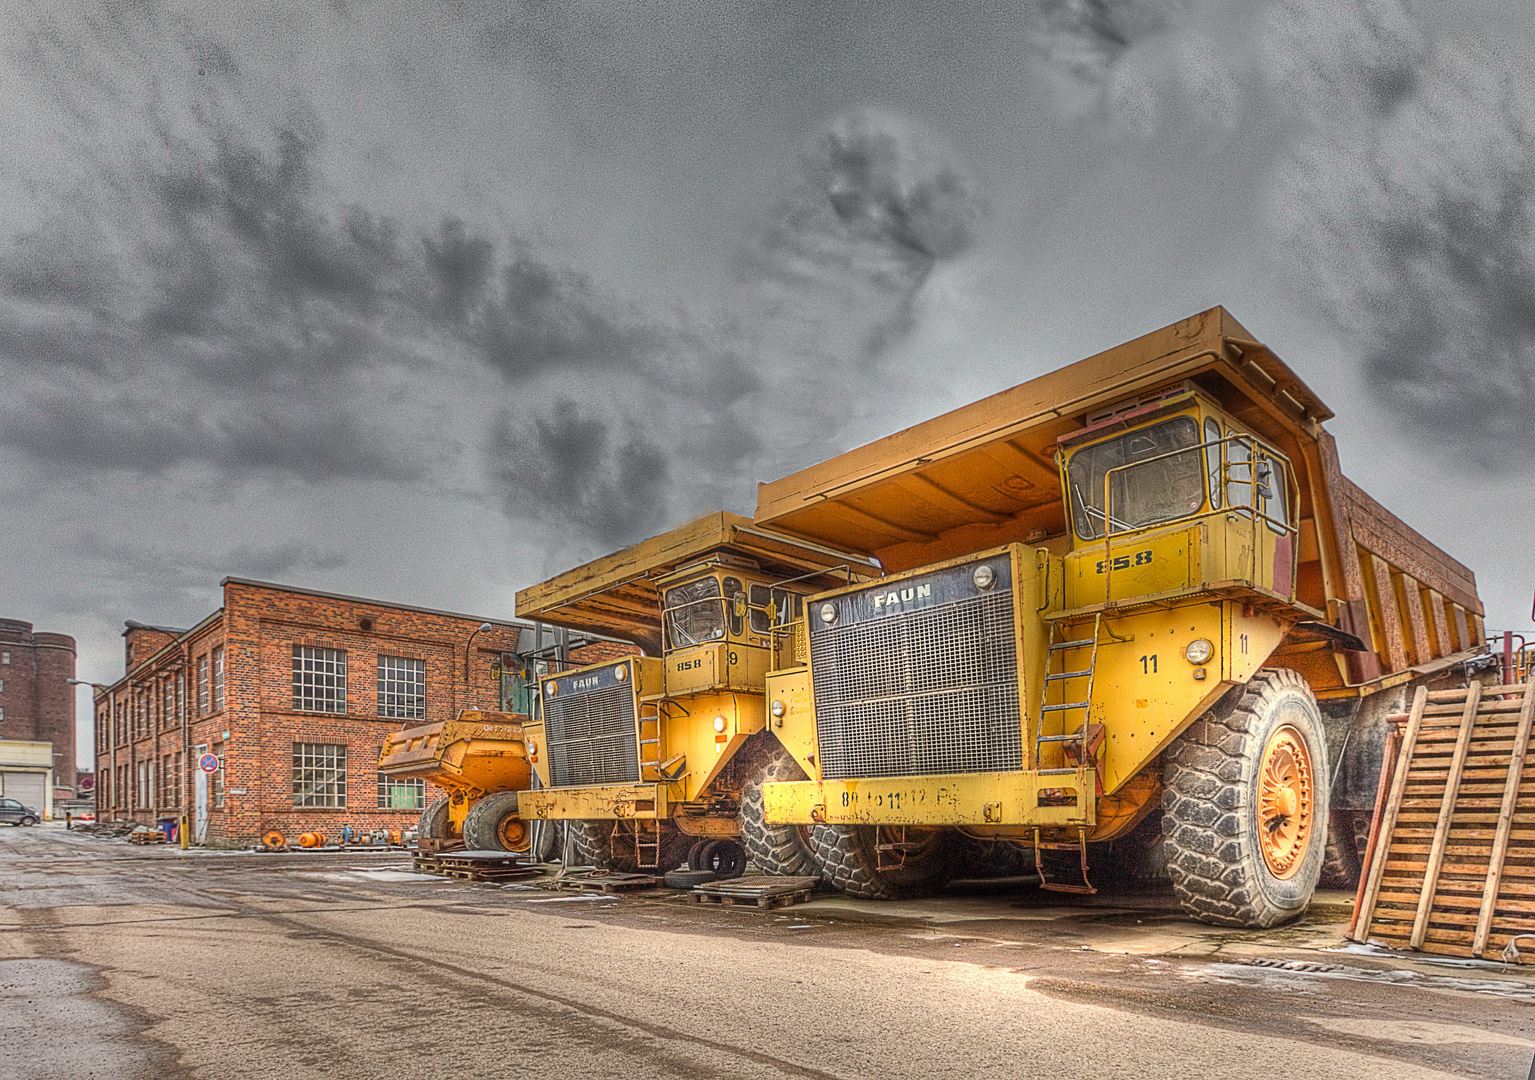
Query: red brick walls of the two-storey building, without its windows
97 581 519 845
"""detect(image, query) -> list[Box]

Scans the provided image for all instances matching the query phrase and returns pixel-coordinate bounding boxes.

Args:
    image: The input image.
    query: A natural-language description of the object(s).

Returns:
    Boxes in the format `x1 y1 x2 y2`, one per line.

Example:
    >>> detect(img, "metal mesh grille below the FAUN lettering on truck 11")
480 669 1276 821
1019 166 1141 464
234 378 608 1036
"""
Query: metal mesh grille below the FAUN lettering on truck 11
810 591 1024 779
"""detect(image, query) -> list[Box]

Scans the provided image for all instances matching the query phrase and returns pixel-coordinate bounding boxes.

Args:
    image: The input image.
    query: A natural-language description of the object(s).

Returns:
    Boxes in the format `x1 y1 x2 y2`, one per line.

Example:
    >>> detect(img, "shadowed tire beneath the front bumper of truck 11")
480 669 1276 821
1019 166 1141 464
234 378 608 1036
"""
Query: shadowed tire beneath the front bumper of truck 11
810 825 955 901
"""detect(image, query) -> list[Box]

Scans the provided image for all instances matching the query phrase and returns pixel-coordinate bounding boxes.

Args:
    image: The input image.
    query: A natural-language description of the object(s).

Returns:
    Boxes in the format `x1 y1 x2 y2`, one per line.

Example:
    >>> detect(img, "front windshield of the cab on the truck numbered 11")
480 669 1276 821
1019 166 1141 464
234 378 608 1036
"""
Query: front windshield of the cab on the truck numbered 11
1067 416 1205 540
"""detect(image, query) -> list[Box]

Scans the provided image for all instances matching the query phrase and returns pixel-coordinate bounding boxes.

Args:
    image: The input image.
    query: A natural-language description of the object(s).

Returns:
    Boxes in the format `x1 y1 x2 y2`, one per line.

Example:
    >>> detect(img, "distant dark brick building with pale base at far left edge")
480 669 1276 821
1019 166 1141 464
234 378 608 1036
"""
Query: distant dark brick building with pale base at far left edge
0 618 75 810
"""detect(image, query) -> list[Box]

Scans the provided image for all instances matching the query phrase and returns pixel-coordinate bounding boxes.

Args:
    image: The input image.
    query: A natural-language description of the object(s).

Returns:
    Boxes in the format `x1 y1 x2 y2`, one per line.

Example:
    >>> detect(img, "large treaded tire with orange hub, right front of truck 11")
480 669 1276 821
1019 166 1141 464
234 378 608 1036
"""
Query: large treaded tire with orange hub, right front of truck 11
1162 667 1328 927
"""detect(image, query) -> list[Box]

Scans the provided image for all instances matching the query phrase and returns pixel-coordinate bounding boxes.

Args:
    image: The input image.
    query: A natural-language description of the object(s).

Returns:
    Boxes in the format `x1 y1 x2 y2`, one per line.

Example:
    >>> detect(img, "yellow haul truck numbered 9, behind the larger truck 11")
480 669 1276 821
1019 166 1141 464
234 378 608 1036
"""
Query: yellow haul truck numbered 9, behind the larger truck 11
517 514 878 876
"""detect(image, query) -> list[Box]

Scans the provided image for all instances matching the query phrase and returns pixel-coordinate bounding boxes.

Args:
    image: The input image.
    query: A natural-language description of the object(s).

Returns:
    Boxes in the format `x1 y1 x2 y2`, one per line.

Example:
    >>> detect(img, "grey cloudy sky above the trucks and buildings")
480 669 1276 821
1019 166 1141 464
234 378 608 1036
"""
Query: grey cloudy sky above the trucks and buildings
0 0 1535 767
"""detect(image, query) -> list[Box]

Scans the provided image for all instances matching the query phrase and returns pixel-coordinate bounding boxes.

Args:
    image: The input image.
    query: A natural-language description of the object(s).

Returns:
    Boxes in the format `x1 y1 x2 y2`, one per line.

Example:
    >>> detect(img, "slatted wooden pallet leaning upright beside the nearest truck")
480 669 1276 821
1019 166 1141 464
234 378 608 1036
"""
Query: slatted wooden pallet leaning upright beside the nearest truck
1349 681 1535 959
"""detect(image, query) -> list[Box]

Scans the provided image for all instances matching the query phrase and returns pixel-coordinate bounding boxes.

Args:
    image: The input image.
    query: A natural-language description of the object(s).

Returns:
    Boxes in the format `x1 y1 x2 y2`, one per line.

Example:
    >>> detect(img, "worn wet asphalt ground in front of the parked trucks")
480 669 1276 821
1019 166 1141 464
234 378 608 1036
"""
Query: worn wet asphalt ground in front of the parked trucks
0 824 1535 1080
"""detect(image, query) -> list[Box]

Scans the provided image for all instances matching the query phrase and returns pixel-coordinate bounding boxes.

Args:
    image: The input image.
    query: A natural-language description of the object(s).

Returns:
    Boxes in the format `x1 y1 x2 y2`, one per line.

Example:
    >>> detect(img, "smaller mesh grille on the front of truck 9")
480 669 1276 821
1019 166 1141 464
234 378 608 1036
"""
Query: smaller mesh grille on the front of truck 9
543 686 640 787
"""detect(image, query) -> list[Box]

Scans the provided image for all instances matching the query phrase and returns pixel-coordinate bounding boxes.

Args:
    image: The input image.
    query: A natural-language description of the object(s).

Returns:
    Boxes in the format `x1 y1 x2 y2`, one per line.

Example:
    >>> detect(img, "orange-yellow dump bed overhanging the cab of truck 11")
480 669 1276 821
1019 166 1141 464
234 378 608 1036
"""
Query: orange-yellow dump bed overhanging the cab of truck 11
755 307 1483 683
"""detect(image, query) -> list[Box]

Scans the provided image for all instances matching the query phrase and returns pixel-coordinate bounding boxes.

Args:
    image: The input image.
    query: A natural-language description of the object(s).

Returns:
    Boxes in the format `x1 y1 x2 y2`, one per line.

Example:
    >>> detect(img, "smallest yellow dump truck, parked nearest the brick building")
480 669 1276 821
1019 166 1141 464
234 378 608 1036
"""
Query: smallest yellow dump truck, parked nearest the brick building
378 710 554 858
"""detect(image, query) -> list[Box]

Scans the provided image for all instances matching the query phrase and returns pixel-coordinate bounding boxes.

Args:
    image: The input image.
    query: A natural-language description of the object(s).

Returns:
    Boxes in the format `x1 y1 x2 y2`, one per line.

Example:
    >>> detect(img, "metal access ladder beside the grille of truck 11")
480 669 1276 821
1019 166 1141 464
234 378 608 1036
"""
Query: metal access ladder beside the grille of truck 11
1035 612 1104 894
